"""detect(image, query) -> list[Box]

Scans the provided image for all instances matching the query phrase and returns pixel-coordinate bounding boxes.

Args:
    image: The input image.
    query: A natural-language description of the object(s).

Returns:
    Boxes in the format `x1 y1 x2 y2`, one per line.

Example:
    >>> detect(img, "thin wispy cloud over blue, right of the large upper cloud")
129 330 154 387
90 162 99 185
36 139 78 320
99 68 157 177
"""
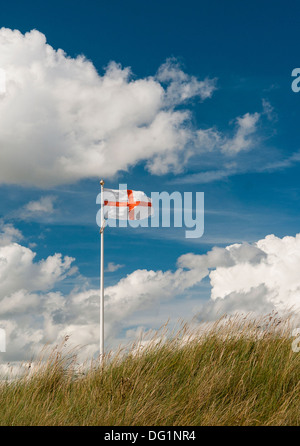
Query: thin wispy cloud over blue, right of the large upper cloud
170 109 268 184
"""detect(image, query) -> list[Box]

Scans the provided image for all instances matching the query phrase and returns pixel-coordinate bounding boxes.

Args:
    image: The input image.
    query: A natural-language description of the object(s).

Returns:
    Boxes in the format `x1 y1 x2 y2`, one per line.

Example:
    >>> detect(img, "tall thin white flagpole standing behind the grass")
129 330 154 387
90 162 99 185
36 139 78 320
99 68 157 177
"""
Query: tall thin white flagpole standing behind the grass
100 180 104 363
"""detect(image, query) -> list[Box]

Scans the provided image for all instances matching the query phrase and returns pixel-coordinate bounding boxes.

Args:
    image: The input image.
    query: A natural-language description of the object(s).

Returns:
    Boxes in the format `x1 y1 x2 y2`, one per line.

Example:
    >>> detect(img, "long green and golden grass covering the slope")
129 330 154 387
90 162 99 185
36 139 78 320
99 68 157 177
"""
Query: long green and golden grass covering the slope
0 317 300 426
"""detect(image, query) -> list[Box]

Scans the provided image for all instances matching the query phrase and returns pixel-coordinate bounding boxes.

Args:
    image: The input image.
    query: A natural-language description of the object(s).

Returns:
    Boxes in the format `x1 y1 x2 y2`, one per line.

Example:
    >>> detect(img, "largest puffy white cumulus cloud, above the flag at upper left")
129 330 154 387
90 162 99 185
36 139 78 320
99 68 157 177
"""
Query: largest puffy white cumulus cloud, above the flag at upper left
0 28 216 188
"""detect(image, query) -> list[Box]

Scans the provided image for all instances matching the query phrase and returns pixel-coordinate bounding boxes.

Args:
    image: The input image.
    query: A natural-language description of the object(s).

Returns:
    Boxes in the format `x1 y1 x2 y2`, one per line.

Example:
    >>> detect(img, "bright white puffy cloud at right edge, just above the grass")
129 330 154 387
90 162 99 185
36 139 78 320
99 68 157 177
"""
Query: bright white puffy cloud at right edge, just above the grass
210 234 300 312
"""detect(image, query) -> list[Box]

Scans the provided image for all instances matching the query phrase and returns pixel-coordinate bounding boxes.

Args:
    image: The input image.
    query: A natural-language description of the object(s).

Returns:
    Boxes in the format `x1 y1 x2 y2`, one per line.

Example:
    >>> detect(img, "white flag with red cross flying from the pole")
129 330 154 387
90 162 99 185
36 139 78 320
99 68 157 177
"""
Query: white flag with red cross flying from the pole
103 189 153 220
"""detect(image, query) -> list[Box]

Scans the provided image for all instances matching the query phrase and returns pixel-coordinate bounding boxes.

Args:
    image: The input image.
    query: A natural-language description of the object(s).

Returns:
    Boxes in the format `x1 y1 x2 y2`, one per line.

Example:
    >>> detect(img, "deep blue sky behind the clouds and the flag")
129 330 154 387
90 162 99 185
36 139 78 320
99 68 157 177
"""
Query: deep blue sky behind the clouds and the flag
0 0 300 362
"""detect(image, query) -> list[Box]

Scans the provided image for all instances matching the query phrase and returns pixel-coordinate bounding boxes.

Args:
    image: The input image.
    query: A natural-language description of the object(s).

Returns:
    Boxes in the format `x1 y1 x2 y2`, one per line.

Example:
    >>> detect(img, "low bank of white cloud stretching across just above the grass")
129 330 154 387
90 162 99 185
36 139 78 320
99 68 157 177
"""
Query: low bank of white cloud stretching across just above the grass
0 221 300 361
